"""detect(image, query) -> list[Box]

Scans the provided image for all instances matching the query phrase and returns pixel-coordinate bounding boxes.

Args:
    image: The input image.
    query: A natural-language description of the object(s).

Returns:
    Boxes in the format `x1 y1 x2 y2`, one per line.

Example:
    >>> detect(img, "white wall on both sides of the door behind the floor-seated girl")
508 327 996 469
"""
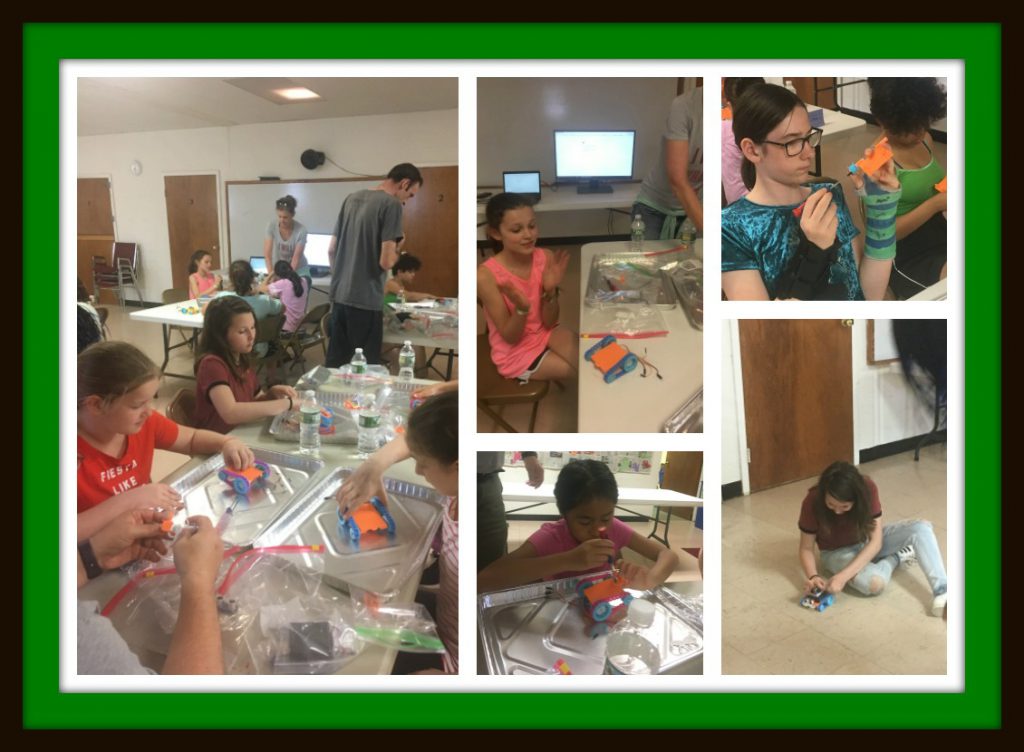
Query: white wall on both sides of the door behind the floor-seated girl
722 319 933 492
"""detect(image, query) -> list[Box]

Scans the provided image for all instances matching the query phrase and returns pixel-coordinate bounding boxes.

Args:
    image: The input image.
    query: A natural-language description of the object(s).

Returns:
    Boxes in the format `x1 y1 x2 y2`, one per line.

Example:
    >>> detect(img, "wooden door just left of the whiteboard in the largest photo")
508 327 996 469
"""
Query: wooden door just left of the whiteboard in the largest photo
164 175 221 290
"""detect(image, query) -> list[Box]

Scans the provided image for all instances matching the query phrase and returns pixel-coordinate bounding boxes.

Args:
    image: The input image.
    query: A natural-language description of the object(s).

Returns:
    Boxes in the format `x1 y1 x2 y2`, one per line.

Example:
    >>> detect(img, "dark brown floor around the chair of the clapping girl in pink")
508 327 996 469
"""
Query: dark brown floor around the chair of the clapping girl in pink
476 247 580 433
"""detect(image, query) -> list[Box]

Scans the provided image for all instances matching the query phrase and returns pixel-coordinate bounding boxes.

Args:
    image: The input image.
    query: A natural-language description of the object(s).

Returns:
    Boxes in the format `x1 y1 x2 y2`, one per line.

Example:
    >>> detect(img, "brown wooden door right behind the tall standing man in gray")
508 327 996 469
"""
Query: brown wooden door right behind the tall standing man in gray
402 167 459 297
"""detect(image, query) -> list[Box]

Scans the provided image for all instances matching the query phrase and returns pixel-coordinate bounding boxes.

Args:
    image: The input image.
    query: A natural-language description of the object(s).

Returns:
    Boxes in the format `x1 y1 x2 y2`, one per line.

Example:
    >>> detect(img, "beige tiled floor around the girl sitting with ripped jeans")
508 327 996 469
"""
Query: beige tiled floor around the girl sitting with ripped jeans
722 445 946 674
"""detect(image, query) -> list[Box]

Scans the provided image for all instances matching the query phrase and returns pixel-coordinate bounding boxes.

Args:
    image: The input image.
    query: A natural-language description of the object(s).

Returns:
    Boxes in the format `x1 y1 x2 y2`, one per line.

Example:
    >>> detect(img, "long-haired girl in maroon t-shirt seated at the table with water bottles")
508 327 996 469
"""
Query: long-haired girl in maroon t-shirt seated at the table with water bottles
195 295 298 431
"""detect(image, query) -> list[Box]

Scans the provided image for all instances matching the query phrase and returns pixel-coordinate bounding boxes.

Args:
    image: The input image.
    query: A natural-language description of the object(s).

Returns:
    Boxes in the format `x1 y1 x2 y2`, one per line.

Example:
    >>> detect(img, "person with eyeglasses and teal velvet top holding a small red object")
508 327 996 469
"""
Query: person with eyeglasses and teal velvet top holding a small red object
722 84 900 300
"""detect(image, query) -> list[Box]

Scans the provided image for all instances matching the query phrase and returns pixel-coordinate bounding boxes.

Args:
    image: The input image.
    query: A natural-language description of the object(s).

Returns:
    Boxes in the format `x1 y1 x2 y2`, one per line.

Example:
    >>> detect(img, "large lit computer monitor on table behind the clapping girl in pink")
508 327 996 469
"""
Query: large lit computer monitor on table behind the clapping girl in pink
555 130 637 194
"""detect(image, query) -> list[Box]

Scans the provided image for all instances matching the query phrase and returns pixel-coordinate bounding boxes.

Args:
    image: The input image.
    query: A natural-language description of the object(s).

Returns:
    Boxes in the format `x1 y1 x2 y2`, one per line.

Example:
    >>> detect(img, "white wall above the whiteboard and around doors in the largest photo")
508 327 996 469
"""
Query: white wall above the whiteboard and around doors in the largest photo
78 110 459 301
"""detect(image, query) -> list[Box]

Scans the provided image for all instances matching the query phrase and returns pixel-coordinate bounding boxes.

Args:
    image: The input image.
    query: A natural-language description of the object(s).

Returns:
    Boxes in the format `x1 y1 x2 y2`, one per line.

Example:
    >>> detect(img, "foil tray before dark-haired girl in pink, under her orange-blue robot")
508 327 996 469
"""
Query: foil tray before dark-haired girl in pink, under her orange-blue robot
477 578 703 674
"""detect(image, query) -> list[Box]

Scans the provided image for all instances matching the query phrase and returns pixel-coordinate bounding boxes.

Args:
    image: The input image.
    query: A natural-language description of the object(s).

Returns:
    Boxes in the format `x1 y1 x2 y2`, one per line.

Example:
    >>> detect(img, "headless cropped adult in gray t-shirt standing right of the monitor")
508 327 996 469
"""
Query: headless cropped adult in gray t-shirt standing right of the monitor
633 87 703 240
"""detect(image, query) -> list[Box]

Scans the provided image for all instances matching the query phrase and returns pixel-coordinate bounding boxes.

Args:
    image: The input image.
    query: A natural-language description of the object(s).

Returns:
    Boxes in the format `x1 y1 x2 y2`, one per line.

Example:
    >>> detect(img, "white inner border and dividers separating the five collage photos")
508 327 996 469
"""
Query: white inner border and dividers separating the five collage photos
59 59 965 693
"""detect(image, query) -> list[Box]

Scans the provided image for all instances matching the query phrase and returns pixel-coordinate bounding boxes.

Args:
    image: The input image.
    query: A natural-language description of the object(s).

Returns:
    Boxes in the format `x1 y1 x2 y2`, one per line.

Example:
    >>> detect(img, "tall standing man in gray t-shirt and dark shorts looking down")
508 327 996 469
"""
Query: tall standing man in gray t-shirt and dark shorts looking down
325 163 423 368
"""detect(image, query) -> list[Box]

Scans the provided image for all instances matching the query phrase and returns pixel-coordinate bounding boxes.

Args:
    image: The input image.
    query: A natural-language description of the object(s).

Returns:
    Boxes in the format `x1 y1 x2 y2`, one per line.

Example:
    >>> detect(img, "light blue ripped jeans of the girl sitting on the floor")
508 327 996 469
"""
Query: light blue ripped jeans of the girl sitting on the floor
821 519 946 595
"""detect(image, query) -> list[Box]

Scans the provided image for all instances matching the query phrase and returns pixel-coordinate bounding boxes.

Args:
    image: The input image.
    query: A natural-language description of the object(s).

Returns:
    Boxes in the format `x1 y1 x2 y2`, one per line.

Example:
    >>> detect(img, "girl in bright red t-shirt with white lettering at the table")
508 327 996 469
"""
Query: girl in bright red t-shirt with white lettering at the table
78 342 253 541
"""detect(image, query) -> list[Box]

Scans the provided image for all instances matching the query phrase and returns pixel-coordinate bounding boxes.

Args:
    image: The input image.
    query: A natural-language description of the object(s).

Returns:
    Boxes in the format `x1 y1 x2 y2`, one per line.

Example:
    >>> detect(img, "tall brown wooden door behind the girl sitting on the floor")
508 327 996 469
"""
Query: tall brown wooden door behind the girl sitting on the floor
739 319 853 492
